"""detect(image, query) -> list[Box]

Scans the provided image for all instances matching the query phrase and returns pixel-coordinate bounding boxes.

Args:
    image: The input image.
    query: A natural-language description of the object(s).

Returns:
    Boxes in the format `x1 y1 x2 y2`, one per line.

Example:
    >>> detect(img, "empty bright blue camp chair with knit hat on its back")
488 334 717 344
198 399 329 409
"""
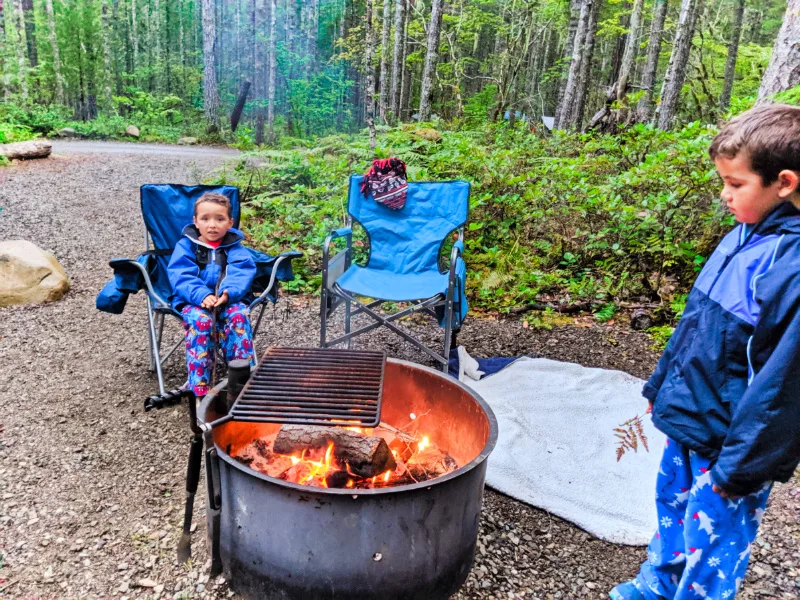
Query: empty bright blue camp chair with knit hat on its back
320 175 469 372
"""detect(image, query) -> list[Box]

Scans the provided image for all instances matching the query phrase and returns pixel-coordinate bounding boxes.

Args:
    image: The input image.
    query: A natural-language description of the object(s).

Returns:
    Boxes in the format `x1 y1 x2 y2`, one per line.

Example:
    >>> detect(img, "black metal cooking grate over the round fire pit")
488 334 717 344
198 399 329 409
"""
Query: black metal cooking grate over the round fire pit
229 348 386 427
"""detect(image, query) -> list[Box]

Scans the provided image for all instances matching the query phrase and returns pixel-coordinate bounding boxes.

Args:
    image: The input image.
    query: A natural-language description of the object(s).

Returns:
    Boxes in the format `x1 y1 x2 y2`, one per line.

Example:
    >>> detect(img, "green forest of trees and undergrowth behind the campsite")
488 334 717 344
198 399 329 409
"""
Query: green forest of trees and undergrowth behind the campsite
0 0 800 341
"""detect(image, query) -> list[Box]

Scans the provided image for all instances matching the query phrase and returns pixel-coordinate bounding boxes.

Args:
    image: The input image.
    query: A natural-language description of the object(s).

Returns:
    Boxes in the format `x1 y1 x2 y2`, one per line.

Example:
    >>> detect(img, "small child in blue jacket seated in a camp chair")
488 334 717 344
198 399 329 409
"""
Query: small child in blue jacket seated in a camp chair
167 193 256 397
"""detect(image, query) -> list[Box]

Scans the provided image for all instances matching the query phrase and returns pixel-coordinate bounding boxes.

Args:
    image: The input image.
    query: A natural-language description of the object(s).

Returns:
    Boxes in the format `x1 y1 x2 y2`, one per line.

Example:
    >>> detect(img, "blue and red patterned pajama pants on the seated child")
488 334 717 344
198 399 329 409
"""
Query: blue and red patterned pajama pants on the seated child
181 302 253 397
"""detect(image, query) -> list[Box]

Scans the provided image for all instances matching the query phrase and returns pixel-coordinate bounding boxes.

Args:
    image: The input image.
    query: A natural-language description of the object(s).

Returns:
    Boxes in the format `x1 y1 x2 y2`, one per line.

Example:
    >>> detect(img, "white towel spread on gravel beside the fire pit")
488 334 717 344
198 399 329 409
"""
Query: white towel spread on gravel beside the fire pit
459 353 665 545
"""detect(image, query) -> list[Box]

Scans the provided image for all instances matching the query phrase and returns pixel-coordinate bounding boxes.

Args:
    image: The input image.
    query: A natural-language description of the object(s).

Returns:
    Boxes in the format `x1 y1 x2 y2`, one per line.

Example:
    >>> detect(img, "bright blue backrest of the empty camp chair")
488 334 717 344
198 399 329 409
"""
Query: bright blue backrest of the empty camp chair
347 175 469 273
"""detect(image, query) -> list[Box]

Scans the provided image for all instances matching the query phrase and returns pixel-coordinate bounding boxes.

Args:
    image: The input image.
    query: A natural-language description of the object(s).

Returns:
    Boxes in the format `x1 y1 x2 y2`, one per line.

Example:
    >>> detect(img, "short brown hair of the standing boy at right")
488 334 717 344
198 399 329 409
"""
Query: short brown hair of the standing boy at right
708 104 800 186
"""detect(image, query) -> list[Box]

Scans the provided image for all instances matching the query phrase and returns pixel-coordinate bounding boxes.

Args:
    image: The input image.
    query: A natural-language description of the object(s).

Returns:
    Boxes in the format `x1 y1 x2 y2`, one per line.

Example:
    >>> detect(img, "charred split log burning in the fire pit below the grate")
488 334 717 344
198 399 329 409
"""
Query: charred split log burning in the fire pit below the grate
272 425 397 477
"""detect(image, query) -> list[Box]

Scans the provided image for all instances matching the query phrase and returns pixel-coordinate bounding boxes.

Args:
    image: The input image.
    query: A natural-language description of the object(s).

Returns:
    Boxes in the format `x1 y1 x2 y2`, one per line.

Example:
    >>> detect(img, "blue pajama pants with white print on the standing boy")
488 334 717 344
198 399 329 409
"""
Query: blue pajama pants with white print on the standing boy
611 439 772 600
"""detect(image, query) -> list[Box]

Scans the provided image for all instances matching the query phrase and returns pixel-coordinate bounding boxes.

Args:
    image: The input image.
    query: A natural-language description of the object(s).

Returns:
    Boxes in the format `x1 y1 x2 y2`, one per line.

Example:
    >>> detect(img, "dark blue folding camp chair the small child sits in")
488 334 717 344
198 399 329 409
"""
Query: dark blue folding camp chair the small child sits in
96 184 302 395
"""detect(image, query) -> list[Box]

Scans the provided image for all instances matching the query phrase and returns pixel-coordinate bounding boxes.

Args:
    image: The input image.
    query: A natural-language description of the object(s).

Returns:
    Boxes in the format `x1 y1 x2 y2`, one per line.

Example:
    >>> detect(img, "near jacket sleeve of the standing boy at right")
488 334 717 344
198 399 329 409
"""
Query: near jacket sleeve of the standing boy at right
711 264 800 495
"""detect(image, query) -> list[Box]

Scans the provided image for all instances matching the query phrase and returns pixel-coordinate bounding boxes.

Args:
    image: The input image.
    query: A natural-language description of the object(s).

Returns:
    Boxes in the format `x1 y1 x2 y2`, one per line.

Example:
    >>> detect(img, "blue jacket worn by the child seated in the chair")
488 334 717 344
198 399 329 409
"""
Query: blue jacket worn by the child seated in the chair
167 225 256 311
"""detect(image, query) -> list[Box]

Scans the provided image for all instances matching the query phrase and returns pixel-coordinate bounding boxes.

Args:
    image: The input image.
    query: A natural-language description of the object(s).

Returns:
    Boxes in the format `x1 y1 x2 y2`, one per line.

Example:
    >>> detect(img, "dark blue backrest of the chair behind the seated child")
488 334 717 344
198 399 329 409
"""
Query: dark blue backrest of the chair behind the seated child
141 184 240 250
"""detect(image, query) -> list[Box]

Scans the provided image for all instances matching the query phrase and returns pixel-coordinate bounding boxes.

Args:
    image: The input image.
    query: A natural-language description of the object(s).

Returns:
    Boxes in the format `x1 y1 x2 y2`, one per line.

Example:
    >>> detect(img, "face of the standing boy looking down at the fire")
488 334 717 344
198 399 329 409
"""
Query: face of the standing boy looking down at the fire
714 152 797 224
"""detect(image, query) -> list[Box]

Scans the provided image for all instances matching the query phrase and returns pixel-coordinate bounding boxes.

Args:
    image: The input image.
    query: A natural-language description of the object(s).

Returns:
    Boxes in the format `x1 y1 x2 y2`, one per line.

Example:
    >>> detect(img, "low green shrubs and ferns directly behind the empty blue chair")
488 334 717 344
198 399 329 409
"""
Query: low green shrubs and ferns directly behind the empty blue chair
219 123 731 321
